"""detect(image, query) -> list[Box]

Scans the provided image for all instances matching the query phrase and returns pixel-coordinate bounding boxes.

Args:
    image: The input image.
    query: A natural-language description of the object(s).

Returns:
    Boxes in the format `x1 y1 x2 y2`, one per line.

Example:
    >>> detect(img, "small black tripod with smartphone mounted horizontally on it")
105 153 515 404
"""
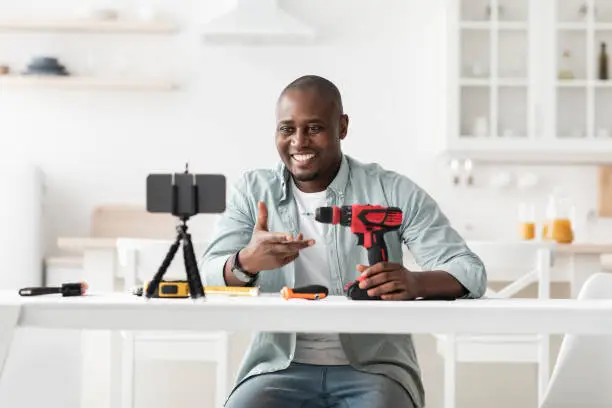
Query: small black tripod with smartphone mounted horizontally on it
145 163 226 298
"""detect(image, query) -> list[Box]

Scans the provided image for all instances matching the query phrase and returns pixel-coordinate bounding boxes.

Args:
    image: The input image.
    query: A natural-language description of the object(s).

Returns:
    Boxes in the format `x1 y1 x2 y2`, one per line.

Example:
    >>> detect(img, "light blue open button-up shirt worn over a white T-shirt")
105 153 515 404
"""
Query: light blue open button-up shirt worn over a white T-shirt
201 155 487 407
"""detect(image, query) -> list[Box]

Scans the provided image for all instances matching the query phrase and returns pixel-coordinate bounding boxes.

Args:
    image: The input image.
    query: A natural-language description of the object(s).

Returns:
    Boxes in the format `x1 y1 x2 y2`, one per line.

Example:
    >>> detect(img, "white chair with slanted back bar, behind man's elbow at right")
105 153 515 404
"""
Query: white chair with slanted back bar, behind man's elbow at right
436 241 553 408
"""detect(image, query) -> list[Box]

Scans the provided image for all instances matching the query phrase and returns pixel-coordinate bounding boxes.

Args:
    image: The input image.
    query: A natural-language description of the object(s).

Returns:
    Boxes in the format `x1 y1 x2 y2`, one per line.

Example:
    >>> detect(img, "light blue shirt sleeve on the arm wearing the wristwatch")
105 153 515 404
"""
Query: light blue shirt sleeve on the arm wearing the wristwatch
200 177 255 286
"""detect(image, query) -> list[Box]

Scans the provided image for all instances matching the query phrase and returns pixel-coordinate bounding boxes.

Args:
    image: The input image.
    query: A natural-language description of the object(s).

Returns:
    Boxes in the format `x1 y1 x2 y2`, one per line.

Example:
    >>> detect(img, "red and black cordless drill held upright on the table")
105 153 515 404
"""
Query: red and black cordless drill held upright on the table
315 204 403 300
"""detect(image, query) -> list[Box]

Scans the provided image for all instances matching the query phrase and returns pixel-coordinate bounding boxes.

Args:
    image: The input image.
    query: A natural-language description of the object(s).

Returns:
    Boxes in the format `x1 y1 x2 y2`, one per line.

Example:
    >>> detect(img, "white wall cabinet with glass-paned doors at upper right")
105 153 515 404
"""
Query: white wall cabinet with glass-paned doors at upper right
444 0 612 163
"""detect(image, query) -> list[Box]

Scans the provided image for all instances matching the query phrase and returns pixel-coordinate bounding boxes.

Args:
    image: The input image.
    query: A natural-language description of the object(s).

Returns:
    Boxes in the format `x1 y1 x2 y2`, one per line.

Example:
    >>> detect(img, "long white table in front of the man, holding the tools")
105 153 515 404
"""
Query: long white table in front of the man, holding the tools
0 291 612 380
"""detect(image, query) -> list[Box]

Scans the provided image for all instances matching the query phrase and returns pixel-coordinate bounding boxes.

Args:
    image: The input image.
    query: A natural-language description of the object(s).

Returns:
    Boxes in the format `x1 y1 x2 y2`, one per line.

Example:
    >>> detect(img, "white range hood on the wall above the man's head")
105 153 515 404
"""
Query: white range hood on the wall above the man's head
204 0 315 43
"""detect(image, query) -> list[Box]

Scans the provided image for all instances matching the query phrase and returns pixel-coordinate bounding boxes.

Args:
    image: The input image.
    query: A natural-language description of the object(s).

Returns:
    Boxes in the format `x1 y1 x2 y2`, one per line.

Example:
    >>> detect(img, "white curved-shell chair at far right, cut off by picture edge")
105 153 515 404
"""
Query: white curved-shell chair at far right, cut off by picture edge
540 273 612 408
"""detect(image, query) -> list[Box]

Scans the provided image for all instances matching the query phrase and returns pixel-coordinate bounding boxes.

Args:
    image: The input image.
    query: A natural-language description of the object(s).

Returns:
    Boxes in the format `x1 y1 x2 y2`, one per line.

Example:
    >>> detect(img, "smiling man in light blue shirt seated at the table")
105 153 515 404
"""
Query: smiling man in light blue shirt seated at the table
202 76 486 408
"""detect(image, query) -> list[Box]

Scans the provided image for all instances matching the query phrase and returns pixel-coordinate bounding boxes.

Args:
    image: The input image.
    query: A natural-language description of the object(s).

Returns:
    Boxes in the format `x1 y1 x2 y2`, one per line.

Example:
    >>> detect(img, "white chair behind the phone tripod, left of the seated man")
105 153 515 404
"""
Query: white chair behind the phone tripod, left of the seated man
117 238 229 408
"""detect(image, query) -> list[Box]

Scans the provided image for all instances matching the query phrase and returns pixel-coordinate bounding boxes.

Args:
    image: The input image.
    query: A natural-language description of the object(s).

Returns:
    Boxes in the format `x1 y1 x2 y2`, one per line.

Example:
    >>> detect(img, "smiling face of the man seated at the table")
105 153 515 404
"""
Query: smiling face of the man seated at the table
276 89 348 186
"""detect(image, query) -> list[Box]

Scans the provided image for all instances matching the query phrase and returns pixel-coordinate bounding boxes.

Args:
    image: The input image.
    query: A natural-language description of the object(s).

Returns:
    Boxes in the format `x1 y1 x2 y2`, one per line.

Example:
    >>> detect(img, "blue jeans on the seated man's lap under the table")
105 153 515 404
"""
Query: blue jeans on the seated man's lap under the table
225 363 414 408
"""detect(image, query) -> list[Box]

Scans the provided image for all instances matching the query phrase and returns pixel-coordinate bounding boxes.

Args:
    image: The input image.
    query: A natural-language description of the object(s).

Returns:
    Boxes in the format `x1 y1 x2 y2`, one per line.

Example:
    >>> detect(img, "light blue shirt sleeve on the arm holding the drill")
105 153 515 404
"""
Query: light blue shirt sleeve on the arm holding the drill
394 180 487 298
